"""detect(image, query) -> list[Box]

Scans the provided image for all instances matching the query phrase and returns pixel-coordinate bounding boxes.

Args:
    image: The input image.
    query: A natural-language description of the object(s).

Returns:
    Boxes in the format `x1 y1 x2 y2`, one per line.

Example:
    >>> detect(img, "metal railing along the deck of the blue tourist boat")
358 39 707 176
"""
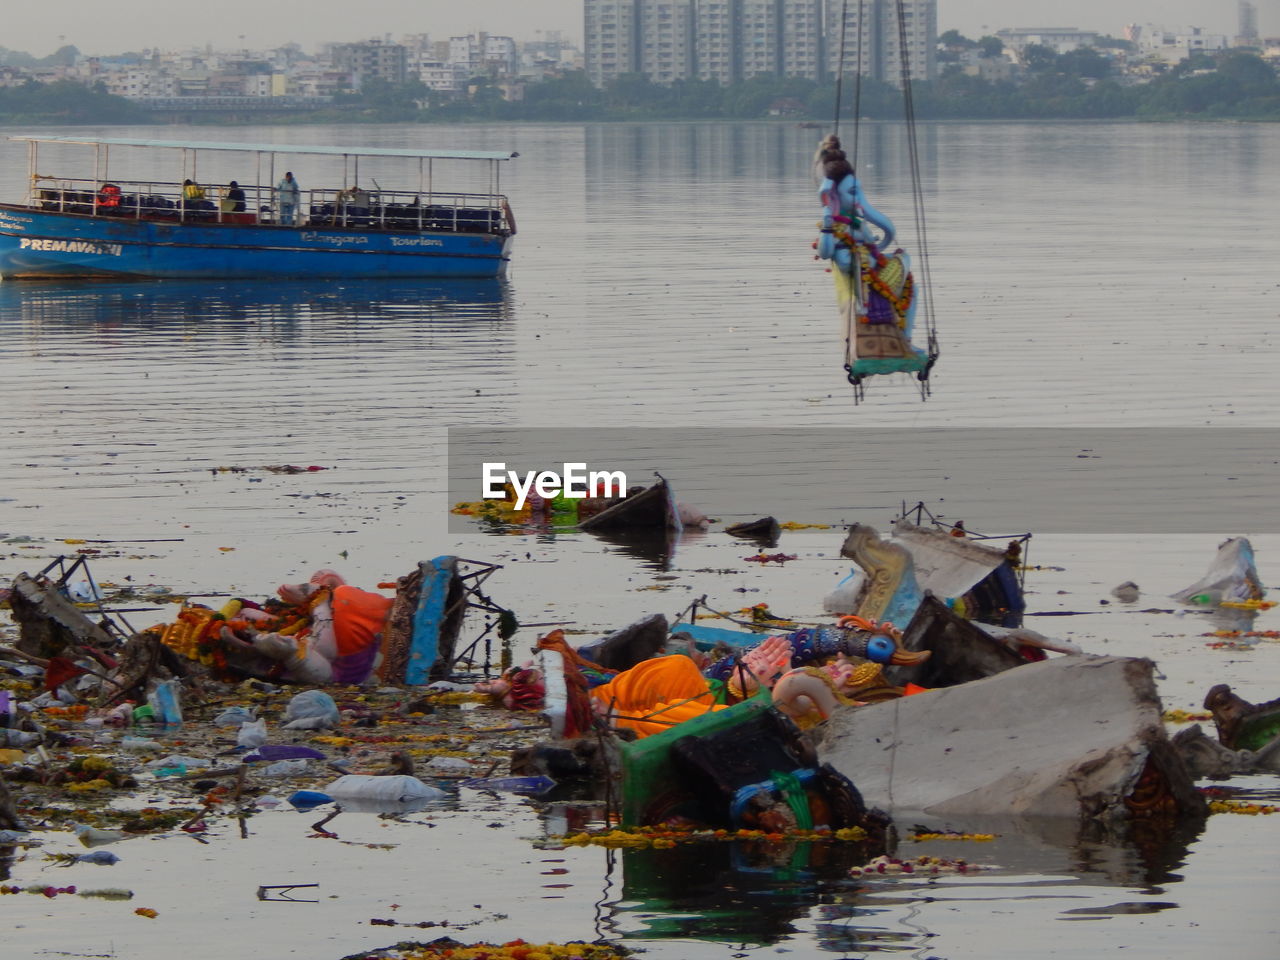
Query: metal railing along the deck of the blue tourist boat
28 177 512 233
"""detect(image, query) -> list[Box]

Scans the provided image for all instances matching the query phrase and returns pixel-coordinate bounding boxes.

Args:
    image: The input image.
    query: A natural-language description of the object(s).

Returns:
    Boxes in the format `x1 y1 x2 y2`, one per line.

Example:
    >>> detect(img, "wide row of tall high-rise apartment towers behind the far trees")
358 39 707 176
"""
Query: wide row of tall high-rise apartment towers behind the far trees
582 0 937 86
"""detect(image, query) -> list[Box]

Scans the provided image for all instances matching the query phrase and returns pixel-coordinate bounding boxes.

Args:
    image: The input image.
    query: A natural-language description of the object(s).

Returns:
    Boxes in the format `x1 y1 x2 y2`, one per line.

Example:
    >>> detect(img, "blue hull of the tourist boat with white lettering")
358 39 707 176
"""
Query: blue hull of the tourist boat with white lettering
0 205 511 279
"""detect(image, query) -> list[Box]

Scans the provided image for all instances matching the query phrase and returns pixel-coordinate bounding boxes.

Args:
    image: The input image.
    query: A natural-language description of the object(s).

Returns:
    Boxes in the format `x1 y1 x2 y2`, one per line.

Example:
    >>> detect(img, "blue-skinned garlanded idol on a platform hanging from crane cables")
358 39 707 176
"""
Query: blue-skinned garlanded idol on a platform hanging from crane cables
815 137 936 396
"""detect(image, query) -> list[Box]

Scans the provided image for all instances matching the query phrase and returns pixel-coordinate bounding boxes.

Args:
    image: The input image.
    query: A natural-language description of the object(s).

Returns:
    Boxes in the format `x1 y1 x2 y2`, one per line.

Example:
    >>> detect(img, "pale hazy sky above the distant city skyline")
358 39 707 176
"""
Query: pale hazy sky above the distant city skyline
0 0 1280 56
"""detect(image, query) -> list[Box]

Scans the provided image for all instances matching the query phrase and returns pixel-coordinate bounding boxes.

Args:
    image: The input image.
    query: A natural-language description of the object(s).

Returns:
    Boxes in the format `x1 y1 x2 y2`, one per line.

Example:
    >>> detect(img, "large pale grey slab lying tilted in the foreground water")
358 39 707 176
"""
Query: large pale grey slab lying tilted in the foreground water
818 657 1203 817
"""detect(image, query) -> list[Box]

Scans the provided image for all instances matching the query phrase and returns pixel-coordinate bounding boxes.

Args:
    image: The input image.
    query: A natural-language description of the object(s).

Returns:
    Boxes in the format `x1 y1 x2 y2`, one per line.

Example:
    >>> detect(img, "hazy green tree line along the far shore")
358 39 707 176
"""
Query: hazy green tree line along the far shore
0 47 1280 123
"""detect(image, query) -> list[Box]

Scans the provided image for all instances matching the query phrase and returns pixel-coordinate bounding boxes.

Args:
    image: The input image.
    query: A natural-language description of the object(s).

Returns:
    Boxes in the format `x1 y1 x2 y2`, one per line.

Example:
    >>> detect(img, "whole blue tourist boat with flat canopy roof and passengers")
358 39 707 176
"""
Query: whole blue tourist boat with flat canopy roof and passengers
0 137 517 279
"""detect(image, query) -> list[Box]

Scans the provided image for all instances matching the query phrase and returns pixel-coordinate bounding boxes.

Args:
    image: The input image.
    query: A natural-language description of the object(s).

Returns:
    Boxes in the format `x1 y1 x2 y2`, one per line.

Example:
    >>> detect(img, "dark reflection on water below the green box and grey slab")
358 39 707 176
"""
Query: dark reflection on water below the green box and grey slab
541 804 1203 952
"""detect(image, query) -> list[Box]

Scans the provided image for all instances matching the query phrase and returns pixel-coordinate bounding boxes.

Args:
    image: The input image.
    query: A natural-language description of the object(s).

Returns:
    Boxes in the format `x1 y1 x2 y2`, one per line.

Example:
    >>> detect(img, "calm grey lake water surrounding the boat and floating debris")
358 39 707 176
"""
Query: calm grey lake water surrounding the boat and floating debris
0 123 1280 960
